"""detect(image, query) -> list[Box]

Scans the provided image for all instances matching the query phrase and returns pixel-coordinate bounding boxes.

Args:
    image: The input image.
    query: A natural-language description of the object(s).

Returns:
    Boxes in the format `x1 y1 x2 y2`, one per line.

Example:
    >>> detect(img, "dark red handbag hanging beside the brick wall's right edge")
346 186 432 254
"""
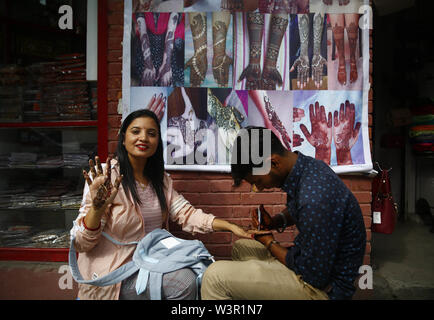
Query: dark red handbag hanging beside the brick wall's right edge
372 163 398 234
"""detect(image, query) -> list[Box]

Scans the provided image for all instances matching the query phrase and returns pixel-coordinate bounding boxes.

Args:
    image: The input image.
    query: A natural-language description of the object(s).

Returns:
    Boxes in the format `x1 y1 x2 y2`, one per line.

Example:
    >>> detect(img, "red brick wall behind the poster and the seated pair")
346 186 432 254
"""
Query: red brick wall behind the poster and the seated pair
107 0 373 264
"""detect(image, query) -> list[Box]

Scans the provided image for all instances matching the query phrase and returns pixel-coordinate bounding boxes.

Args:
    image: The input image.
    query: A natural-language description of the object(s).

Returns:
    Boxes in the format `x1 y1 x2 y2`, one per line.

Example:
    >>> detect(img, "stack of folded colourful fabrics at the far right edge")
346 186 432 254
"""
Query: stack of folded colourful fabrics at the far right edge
409 102 434 155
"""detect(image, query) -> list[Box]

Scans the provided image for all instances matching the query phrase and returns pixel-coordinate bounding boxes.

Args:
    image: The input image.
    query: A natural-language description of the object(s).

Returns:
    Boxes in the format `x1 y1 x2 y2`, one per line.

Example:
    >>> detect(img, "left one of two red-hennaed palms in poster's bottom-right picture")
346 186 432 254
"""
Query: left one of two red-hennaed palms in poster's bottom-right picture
300 101 333 164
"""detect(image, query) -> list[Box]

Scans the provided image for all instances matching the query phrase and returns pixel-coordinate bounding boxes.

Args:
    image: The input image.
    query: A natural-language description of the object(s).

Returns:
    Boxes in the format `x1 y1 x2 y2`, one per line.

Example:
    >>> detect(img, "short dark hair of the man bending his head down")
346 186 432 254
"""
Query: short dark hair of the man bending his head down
231 126 288 186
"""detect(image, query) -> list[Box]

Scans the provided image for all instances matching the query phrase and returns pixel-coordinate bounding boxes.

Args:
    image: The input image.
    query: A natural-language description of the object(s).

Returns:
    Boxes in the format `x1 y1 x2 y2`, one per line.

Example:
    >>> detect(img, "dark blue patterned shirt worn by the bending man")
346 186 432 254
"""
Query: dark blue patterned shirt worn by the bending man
282 152 366 299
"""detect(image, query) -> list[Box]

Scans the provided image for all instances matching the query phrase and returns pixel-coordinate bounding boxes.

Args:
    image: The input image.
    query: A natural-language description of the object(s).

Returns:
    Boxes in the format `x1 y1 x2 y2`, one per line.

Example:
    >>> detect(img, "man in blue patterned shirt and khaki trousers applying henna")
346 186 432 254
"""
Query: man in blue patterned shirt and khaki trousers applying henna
202 127 366 300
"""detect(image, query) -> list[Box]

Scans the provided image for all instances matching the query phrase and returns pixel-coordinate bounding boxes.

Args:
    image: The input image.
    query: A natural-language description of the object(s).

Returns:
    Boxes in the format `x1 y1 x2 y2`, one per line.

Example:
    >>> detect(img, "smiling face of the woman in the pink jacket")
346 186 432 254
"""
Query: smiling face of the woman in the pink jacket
123 117 159 159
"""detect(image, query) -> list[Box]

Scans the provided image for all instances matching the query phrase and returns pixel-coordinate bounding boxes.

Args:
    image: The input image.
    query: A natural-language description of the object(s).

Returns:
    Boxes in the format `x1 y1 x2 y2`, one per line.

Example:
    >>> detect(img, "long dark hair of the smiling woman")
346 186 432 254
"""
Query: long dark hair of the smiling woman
116 109 168 215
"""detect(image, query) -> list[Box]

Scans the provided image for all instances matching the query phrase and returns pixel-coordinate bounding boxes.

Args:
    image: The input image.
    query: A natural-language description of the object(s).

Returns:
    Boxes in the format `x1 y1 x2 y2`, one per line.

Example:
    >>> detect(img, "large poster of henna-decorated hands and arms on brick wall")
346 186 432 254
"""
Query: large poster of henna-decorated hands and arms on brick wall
122 0 372 173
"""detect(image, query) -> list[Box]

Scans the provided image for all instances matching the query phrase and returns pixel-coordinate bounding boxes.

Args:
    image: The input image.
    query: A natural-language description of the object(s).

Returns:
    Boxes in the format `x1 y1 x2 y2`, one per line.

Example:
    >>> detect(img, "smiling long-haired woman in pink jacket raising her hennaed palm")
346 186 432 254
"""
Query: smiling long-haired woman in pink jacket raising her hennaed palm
71 109 257 300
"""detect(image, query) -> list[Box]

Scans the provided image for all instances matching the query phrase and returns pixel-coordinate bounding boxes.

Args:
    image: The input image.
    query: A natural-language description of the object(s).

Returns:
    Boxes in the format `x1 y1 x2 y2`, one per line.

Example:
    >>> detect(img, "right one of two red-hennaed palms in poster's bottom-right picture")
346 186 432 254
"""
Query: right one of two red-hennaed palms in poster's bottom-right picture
333 100 361 165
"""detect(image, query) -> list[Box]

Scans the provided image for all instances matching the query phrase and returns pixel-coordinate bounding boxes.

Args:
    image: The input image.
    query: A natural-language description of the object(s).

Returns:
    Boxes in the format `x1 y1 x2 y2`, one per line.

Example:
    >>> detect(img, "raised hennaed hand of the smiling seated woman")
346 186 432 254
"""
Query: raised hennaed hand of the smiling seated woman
83 157 122 211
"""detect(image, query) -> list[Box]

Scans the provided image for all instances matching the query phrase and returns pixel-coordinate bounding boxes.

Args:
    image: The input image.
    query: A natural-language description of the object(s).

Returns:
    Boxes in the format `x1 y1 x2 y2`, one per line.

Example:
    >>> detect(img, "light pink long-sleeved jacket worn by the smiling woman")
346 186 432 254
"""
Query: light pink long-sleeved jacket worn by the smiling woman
71 160 215 300
